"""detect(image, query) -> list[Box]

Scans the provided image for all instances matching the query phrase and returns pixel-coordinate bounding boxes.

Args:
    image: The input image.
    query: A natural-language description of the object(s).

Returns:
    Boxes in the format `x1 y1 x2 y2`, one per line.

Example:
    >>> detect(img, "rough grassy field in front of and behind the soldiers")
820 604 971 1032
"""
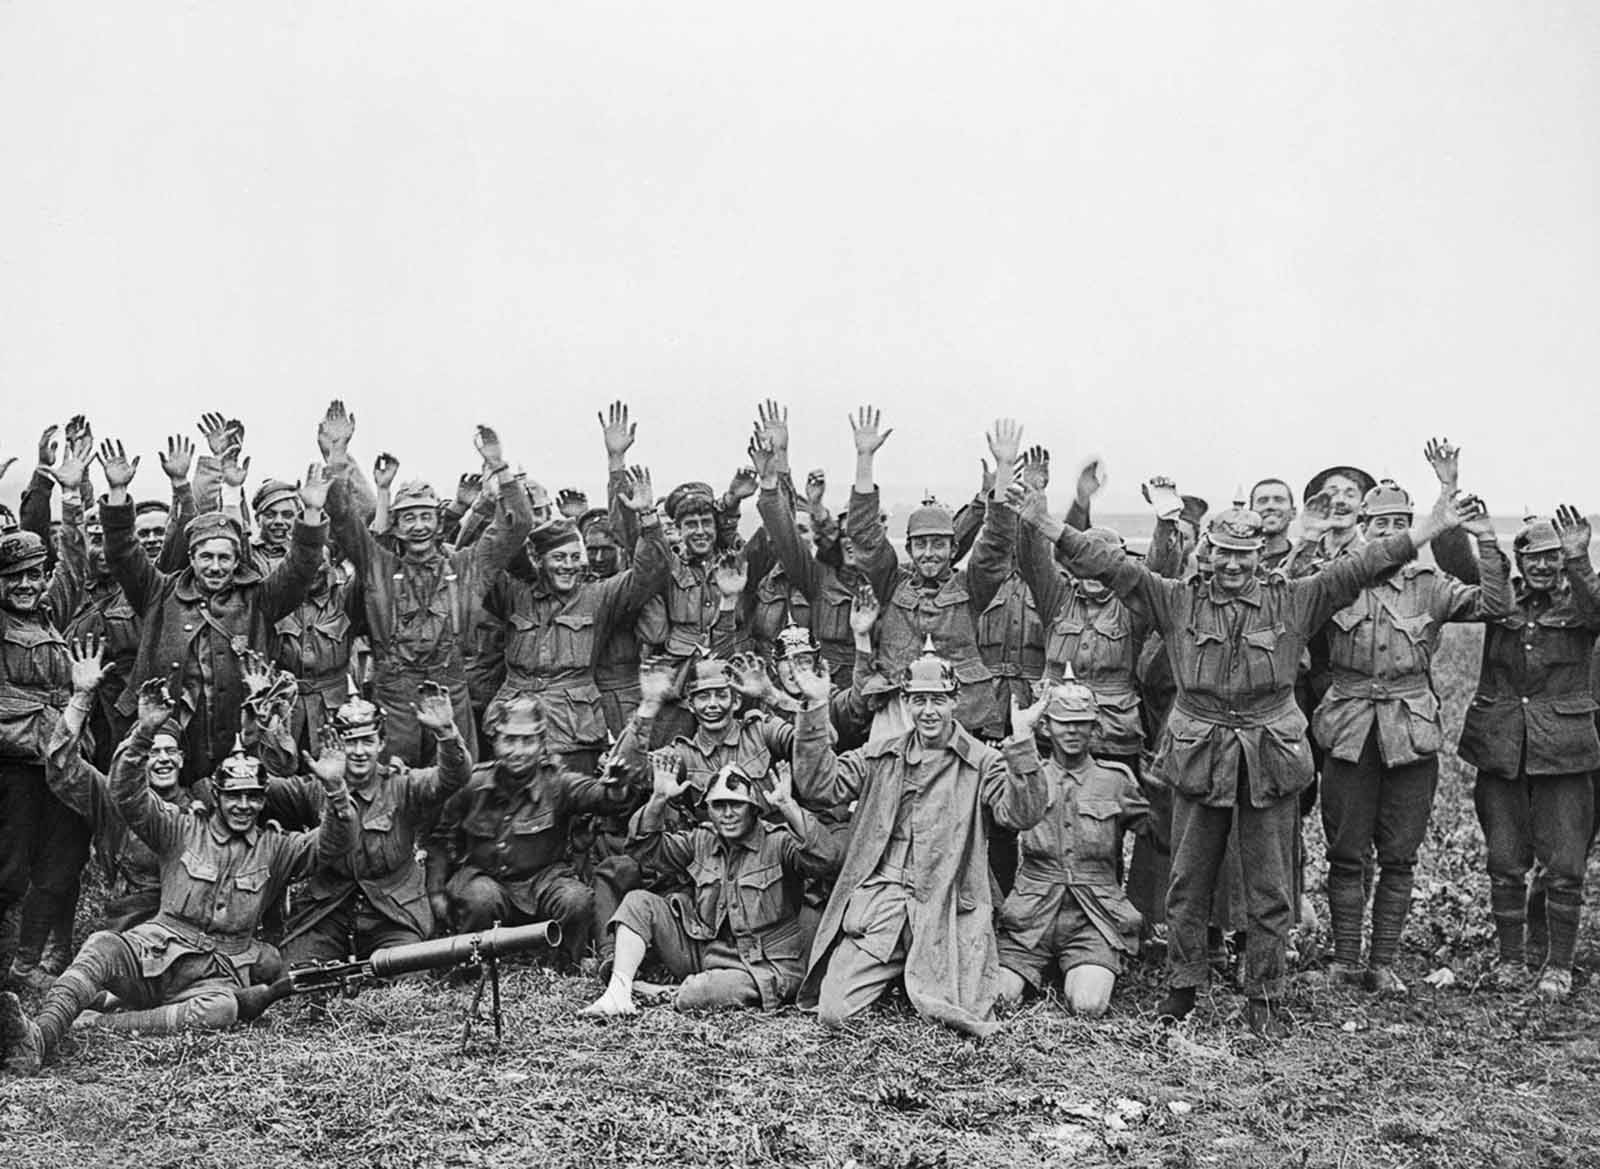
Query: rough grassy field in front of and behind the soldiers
0 632 1600 1169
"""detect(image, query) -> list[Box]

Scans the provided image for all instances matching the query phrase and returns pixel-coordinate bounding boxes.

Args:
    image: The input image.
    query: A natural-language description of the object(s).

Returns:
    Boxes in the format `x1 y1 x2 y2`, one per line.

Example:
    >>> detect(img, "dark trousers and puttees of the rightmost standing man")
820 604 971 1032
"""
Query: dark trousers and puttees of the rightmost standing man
1472 771 1595 969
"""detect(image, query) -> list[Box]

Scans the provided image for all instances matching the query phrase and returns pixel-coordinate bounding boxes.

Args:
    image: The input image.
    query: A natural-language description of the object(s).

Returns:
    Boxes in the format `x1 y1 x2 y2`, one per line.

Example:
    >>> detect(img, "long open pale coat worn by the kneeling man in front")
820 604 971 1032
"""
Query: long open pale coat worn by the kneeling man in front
794 705 1045 1035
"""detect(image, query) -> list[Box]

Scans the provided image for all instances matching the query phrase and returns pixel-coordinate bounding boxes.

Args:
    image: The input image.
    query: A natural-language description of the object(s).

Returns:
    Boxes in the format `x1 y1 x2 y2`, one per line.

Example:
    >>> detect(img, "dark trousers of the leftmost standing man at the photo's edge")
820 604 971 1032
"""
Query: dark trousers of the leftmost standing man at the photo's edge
0 763 90 979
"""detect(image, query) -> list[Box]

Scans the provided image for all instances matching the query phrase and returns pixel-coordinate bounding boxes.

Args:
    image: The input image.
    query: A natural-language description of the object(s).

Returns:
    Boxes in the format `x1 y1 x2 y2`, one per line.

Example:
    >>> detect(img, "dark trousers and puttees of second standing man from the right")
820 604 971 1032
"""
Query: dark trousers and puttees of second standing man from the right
1322 726 1438 966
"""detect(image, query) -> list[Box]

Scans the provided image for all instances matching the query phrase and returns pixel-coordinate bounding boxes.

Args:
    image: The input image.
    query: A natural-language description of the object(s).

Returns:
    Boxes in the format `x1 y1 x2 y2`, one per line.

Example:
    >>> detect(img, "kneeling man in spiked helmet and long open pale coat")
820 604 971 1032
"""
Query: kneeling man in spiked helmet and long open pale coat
794 644 1046 1036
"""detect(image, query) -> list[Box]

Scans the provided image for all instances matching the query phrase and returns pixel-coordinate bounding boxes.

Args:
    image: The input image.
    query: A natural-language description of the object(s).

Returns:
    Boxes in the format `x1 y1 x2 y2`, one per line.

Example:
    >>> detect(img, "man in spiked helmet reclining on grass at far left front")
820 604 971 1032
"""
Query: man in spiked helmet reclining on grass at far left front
0 678 352 1075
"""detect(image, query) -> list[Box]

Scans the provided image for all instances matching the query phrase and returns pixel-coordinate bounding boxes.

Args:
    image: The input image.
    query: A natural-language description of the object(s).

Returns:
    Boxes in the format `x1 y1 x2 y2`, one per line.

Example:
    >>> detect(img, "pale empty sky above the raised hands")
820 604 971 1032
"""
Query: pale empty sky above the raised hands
0 0 1600 513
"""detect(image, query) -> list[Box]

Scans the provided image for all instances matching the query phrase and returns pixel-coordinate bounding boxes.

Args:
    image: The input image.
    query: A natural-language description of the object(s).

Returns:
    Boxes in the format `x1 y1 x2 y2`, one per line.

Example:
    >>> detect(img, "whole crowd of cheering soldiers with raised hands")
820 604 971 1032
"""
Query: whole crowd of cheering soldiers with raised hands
0 401 1600 1073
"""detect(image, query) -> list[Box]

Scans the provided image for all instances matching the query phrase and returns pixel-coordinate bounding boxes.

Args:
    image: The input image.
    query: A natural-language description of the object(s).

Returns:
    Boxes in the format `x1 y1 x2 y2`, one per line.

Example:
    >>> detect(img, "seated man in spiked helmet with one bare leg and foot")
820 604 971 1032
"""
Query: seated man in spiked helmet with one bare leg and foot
582 750 840 1015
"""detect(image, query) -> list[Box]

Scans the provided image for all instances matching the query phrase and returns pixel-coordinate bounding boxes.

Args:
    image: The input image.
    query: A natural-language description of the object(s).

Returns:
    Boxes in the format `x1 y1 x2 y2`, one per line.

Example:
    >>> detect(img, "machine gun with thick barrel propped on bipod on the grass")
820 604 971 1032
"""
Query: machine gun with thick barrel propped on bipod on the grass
249 921 562 1043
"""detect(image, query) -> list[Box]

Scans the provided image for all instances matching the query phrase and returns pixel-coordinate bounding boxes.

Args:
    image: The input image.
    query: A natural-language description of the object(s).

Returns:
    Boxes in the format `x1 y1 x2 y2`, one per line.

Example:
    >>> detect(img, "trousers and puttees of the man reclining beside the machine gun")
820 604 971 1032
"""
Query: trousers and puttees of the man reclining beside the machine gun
35 929 243 1052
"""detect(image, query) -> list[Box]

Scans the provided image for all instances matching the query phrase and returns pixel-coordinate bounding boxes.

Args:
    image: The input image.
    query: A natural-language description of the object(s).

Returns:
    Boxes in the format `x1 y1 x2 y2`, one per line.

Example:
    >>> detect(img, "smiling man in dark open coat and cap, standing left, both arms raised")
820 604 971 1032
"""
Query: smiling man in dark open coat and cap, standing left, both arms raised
101 440 328 776
